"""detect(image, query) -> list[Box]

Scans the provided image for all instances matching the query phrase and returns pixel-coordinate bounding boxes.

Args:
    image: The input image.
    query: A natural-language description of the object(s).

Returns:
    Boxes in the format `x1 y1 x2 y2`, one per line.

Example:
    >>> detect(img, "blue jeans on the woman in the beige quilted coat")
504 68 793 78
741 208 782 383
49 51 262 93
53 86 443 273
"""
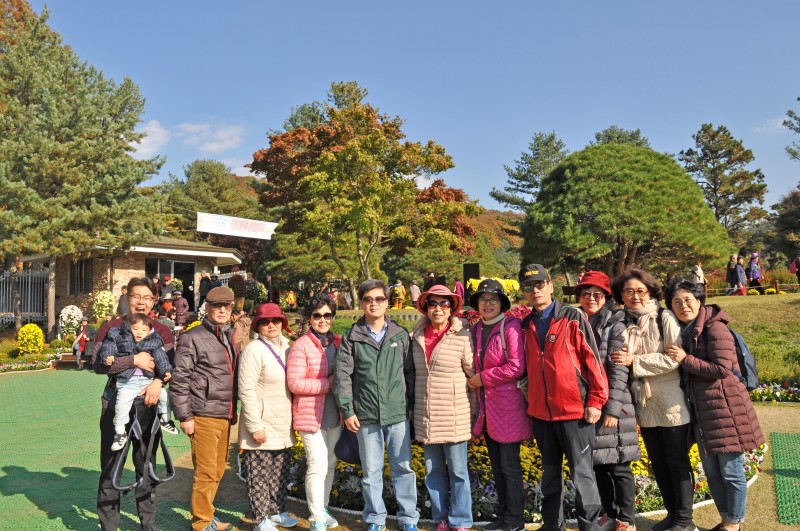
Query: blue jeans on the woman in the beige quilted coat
425 441 472 528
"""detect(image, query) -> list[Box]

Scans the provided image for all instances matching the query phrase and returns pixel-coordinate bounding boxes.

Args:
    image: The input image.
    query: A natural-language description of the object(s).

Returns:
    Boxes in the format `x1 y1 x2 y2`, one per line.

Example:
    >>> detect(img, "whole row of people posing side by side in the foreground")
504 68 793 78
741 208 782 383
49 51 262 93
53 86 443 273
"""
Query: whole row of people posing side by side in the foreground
93 264 764 531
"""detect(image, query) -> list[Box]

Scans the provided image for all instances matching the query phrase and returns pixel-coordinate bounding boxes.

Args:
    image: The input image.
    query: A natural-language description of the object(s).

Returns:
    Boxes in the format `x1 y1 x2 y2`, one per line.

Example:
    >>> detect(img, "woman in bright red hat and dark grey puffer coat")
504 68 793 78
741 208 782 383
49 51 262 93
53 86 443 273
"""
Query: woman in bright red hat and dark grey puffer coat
575 271 641 531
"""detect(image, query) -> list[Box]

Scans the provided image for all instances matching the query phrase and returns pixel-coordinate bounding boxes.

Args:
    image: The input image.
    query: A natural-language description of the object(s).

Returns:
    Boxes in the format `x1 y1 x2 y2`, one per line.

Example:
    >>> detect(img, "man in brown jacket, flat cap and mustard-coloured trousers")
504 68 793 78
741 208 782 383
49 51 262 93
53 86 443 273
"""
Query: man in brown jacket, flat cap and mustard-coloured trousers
170 286 238 531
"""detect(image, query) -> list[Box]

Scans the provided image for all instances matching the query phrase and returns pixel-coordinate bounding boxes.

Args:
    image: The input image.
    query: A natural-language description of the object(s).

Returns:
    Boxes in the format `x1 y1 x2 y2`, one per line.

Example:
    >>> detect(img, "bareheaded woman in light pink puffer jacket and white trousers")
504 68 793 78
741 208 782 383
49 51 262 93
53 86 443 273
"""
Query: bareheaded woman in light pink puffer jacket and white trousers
286 294 342 531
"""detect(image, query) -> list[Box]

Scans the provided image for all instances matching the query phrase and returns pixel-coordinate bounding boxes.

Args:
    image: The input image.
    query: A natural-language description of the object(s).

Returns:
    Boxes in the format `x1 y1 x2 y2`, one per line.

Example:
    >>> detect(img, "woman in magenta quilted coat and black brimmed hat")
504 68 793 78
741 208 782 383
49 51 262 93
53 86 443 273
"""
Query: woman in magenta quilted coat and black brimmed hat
468 279 533 531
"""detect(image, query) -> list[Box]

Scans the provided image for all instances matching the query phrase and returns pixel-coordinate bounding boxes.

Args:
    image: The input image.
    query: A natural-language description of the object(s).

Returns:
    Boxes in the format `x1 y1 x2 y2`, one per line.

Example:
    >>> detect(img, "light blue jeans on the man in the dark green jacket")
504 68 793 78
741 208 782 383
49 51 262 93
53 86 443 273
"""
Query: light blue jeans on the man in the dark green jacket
356 420 419 525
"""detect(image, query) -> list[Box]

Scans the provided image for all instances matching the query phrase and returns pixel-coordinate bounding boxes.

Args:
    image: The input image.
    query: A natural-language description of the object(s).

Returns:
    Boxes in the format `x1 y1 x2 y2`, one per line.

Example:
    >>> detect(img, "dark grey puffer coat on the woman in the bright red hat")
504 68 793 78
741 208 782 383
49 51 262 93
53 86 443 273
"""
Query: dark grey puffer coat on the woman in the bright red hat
592 305 641 466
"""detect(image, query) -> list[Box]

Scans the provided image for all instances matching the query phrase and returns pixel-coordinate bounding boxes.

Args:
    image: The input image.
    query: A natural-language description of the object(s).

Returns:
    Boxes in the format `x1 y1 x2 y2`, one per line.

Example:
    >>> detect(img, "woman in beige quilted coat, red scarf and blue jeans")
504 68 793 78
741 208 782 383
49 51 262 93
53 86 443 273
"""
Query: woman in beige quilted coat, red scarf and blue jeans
411 286 475 531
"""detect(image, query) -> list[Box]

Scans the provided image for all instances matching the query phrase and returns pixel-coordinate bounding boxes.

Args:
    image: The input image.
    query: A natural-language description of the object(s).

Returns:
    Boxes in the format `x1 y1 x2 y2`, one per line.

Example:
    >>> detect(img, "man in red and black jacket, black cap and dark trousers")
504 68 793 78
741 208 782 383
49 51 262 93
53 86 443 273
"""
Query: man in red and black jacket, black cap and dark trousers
519 264 608 531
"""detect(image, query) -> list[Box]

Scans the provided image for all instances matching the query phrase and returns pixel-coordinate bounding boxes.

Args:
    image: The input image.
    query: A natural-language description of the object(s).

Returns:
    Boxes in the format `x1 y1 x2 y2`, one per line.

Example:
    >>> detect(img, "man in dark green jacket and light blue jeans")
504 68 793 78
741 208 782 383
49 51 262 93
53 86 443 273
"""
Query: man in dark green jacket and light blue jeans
334 280 419 531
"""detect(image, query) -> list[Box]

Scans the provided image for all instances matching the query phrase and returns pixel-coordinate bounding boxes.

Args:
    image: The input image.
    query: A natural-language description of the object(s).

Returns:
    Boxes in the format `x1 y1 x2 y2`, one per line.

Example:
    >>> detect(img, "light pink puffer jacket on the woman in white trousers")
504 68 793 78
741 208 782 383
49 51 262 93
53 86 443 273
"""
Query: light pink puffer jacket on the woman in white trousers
286 330 342 432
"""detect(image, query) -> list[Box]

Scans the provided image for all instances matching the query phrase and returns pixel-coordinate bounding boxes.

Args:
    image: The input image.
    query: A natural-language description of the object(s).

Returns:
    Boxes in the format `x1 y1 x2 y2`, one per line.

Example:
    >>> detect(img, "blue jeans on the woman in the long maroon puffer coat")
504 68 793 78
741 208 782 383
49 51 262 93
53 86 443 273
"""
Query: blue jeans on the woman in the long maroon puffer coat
695 428 747 524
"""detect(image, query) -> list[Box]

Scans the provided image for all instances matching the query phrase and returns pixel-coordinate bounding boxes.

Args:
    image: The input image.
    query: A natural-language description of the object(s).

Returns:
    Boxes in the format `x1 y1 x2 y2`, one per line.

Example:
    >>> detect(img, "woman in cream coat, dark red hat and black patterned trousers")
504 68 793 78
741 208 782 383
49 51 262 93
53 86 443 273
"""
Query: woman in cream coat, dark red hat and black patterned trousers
239 303 297 531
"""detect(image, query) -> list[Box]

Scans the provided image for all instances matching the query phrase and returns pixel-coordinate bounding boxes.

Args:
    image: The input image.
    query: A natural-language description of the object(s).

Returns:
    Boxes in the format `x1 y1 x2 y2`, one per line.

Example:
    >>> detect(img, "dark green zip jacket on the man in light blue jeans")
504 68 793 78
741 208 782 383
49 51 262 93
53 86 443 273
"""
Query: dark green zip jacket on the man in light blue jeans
333 317 414 426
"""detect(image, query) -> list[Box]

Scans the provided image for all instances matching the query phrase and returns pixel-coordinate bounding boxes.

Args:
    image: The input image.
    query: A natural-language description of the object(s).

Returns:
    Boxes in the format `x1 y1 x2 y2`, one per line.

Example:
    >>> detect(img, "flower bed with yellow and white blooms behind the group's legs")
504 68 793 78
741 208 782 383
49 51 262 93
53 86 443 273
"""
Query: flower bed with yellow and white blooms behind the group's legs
287 438 764 523
